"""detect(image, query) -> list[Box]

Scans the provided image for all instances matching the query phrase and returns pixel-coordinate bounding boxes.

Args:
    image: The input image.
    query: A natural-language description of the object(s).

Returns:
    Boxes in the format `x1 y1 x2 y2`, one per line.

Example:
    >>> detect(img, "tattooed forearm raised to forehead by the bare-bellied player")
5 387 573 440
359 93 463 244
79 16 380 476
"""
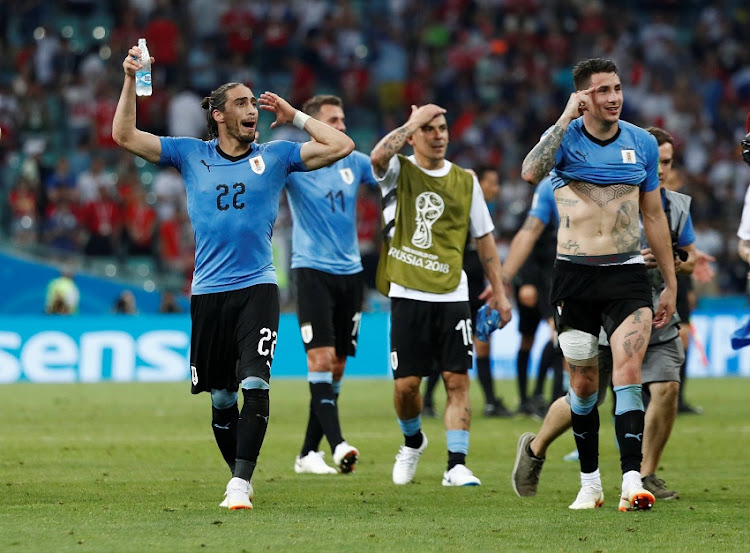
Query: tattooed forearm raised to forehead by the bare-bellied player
521 88 594 185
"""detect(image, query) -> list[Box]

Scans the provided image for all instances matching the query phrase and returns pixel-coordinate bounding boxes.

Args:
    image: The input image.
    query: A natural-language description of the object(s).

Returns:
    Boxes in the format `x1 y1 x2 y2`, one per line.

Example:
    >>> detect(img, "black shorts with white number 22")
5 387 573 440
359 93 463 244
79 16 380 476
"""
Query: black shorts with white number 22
190 284 279 394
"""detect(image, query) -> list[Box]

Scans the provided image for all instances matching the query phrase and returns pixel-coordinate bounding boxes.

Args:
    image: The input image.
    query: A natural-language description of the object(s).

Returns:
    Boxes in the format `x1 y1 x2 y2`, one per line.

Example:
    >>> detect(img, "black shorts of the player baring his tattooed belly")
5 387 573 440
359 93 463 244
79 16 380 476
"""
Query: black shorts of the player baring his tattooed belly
551 259 653 338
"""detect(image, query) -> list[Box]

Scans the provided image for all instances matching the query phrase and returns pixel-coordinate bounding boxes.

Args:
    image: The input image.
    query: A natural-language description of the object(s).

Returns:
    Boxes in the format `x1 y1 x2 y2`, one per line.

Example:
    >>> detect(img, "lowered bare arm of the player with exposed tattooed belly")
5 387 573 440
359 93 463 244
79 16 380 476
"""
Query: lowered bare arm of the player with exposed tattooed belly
640 188 677 328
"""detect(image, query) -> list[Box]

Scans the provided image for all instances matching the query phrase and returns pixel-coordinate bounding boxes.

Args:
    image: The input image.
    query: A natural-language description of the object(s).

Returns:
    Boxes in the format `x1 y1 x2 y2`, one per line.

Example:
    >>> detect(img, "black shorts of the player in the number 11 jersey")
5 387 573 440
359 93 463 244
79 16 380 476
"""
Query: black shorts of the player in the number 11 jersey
292 268 364 357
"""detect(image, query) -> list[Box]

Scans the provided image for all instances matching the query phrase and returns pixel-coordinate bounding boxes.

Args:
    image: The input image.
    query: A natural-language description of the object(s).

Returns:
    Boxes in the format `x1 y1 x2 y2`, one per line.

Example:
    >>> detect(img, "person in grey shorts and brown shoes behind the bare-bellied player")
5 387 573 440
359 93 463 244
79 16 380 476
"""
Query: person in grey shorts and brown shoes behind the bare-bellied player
511 127 698 504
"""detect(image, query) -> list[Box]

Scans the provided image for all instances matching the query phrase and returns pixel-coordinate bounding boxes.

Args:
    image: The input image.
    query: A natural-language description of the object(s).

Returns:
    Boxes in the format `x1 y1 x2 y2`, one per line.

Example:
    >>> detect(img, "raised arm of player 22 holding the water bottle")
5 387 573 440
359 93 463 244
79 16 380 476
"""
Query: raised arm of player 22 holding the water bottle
112 46 161 163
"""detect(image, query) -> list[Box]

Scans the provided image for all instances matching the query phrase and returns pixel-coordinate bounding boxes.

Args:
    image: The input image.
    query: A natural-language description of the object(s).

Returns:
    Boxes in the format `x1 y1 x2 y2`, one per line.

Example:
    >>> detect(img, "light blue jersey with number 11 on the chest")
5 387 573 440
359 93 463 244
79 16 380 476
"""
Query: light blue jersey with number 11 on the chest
286 152 378 275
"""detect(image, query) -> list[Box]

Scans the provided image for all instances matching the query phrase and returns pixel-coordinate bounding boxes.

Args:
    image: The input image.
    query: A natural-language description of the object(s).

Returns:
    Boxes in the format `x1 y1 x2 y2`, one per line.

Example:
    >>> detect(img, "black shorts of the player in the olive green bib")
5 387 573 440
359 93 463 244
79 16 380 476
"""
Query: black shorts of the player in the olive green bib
391 298 473 378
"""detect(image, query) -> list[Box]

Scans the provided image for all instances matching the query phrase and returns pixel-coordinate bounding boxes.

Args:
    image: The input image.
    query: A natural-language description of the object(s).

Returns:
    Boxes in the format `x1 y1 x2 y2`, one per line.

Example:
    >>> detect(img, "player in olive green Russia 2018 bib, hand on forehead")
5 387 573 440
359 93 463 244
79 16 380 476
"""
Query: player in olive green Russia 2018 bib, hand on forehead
370 104 510 486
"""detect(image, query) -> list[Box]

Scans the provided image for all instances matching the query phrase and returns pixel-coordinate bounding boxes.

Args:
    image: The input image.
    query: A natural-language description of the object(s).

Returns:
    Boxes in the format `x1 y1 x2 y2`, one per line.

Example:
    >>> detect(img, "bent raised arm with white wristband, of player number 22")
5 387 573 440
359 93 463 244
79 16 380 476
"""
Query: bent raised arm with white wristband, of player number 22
258 92 354 170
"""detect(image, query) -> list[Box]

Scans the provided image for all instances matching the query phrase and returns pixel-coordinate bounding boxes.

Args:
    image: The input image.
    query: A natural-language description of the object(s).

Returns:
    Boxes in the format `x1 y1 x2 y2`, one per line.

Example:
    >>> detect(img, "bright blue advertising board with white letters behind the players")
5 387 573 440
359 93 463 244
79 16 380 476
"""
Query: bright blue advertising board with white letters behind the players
0 311 750 383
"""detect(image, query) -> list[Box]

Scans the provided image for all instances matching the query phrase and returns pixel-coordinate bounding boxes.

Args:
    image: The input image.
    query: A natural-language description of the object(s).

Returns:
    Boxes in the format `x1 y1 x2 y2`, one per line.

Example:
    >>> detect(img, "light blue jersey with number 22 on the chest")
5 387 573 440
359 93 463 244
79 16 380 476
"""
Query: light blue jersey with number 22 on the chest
159 137 306 295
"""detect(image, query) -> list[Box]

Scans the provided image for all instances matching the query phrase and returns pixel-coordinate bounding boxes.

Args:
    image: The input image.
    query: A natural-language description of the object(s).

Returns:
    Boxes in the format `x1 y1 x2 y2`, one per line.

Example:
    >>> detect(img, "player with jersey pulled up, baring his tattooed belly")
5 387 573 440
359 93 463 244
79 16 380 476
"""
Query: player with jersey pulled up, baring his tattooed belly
522 58 677 510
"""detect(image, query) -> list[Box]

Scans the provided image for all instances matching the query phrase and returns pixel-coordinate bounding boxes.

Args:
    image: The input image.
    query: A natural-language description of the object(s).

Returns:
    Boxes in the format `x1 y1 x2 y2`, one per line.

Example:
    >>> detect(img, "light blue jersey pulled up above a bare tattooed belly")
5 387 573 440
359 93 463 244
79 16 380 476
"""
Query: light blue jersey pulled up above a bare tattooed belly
545 117 659 192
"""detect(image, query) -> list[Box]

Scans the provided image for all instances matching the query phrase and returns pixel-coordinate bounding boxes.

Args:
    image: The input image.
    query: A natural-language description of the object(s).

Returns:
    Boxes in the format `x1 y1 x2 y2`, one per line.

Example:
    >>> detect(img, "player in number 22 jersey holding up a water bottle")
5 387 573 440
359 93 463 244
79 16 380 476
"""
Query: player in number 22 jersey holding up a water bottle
112 46 354 510
